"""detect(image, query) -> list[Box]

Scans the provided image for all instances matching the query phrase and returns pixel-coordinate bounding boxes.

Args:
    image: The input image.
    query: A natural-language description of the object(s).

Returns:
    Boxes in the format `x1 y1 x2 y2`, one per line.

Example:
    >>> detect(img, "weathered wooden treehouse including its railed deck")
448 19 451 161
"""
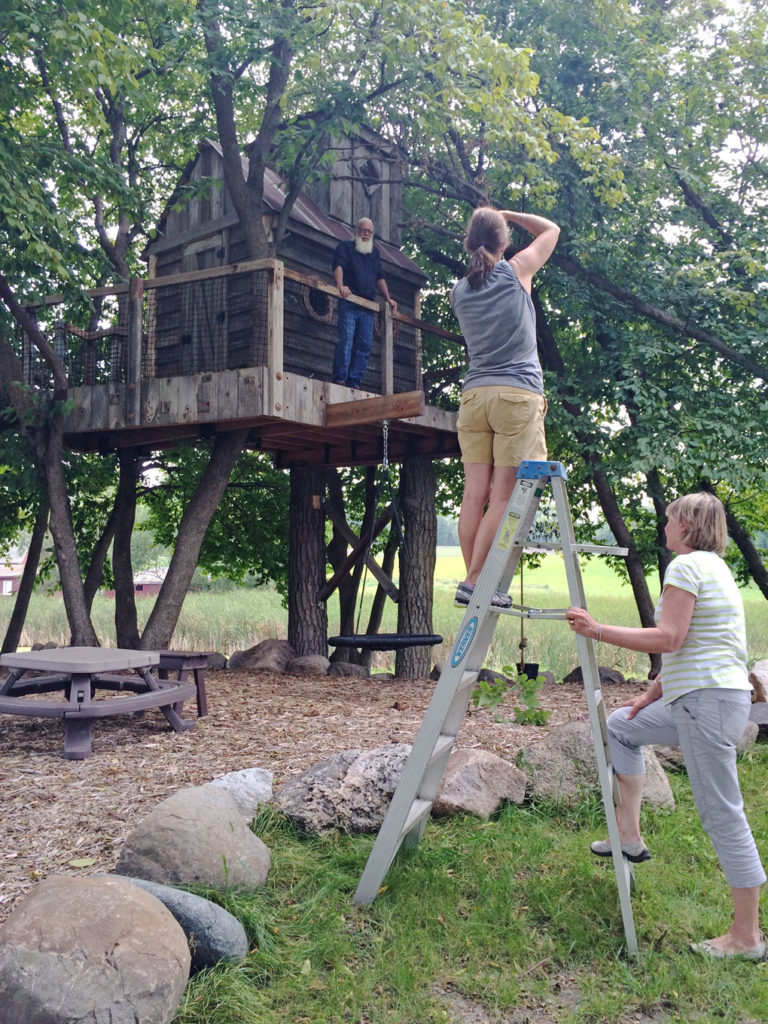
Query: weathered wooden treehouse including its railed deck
25 133 459 467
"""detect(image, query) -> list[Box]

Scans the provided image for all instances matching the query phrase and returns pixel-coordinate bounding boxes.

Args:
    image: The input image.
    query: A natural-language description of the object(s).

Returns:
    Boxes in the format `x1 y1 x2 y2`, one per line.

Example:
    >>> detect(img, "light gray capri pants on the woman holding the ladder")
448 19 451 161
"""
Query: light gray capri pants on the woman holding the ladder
608 688 766 889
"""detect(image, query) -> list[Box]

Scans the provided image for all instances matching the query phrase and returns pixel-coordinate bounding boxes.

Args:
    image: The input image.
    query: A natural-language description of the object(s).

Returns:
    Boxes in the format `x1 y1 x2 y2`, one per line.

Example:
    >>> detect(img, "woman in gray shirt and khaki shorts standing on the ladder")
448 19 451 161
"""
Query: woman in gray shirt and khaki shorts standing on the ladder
451 207 560 607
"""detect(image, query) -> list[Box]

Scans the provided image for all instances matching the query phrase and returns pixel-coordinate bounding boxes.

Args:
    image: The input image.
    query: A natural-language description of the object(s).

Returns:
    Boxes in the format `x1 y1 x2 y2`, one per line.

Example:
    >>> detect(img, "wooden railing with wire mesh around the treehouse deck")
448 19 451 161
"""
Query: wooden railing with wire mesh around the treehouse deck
22 259 463 424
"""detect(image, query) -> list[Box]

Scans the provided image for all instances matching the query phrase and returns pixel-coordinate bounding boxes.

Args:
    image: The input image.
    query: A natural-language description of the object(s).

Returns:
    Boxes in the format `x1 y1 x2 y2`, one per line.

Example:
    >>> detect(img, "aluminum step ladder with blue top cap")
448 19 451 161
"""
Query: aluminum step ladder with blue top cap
353 462 637 955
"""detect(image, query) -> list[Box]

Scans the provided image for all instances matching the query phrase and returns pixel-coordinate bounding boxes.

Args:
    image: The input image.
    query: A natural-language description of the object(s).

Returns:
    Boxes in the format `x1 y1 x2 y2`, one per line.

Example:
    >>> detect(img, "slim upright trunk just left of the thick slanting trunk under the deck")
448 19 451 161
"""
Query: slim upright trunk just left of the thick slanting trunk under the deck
112 452 142 650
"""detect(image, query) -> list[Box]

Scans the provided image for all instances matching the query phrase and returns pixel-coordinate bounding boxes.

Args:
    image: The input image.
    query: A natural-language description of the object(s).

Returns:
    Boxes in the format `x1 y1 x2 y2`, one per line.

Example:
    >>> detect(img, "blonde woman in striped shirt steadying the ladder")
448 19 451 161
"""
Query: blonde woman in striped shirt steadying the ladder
566 493 766 961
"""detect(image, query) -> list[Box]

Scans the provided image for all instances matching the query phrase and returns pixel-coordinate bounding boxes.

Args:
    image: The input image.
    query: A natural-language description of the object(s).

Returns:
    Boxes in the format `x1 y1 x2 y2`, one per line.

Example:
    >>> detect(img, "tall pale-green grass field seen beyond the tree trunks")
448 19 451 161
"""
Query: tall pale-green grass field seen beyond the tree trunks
0 547 768 679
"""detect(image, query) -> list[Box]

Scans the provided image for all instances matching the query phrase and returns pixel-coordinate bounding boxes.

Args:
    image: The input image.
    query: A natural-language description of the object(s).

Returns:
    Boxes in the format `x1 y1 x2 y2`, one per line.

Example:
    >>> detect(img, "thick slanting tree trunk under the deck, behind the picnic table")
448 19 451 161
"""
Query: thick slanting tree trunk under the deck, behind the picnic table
140 430 249 650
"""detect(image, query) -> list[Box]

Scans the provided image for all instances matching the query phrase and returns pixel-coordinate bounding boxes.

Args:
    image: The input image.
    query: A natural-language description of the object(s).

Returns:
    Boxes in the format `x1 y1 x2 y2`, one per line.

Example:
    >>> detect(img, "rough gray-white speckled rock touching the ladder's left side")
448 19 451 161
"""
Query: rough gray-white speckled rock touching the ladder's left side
274 743 411 833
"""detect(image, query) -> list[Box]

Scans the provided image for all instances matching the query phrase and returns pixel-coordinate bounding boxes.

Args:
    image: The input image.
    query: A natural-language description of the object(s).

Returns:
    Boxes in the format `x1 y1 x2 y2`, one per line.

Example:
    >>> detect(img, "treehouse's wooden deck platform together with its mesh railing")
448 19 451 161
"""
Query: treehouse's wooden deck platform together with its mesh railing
24 259 461 467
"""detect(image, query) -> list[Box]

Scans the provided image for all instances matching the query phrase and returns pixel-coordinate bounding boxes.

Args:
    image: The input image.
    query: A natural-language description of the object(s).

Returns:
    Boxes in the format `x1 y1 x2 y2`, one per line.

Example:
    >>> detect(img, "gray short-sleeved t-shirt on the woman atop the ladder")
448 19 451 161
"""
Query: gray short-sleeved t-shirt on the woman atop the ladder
451 259 544 394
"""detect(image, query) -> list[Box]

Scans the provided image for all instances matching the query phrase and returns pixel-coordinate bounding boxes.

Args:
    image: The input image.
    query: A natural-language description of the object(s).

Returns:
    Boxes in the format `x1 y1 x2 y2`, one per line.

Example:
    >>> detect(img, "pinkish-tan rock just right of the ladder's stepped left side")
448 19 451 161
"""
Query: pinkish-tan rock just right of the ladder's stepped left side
432 750 526 818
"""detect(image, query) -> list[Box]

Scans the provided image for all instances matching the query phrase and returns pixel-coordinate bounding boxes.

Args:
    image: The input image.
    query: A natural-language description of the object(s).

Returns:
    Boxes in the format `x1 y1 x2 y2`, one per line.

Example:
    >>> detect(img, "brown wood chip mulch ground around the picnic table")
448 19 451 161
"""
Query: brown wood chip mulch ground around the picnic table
0 670 651 921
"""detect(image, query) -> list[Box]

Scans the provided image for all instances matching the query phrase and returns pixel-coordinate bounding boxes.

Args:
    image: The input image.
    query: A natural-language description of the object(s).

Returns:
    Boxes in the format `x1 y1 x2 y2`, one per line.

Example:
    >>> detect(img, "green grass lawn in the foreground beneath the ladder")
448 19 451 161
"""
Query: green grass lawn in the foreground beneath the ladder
176 745 768 1024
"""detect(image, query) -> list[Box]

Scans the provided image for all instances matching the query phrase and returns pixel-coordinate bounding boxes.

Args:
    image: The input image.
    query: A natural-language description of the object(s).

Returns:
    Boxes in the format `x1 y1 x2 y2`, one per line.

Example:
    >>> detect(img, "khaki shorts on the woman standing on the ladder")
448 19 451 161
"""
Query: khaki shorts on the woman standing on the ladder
458 384 547 466
